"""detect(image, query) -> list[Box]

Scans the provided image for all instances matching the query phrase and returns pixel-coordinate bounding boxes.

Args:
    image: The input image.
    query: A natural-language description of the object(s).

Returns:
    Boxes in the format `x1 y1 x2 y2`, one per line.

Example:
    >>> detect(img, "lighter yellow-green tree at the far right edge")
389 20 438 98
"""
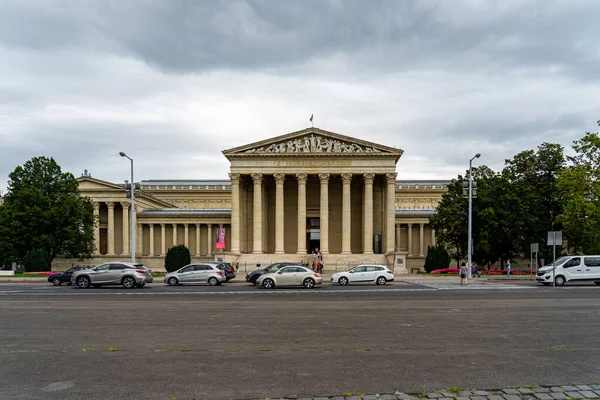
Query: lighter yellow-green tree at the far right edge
557 121 600 254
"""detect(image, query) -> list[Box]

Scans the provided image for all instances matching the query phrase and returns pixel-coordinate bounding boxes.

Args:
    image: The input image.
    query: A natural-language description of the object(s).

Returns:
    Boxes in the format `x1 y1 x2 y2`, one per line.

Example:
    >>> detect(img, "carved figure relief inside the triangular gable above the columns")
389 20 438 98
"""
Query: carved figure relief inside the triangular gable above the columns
244 135 381 154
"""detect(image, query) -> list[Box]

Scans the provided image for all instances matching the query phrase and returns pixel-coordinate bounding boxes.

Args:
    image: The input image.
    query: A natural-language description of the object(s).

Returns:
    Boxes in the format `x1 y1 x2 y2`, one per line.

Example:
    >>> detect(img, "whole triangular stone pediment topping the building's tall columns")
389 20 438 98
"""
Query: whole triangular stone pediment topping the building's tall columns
223 128 403 157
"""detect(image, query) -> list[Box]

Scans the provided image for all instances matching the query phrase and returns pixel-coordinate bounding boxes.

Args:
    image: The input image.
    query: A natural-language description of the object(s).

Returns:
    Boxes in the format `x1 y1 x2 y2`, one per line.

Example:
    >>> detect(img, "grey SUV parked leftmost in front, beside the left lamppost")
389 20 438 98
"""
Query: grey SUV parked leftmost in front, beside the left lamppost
71 262 154 289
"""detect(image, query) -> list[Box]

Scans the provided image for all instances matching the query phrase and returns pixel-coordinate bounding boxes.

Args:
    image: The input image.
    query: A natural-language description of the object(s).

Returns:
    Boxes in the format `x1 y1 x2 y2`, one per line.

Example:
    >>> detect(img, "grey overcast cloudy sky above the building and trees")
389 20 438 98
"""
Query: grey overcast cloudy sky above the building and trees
0 0 600 191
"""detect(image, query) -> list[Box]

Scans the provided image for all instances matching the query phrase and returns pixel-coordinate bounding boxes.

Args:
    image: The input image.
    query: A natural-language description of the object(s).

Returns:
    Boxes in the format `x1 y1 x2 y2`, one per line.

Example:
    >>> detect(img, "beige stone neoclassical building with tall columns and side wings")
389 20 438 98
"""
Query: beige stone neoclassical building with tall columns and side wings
67 128 448 273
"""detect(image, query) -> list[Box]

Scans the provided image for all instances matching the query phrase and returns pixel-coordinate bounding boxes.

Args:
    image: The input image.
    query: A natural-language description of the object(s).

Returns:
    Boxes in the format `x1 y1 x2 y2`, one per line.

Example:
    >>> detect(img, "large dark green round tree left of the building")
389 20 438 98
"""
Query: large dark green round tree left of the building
0 157 95 263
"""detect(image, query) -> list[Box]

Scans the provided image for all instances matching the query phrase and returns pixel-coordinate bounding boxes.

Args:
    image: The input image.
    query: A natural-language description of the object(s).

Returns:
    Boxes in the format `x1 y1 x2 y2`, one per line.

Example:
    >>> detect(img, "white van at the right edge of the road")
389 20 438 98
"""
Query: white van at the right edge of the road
535 256 600 286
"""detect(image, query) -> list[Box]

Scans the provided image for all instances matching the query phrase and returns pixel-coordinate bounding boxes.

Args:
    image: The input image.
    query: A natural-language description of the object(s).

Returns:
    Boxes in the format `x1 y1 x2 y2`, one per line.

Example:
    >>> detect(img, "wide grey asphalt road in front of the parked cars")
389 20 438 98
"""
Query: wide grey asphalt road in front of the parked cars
0 282 600 400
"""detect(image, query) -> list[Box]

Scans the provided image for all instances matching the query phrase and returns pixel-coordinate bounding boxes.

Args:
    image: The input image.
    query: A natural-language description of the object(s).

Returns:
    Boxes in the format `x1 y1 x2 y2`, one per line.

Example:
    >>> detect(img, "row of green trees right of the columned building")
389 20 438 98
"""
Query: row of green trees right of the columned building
430 121 600 266
